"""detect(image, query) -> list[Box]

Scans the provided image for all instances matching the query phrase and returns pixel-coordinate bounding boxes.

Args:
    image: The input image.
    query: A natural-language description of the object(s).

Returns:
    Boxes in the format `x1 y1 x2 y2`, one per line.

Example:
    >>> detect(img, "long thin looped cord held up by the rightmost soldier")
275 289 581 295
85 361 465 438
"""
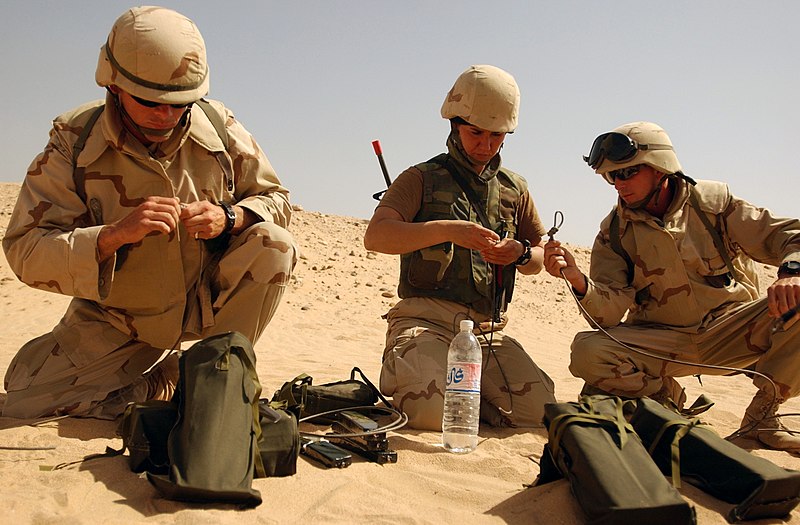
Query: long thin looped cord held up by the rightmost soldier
547 211 800 440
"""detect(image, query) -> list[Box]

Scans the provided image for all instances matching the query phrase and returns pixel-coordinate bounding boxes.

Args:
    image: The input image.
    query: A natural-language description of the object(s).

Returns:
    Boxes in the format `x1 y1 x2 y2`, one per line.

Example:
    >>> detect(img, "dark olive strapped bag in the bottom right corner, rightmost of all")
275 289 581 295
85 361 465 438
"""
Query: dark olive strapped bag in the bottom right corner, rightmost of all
631 398 800 523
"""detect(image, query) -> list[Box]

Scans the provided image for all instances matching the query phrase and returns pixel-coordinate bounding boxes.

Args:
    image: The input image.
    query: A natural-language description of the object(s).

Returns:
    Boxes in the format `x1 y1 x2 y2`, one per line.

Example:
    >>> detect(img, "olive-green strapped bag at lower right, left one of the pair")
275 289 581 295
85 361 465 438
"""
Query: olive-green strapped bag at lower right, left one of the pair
536 396 696 525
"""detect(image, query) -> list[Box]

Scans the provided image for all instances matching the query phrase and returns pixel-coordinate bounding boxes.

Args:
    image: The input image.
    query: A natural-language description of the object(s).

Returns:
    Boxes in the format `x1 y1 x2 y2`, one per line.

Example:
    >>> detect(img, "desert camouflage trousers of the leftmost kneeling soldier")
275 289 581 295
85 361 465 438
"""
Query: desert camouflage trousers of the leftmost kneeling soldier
3 222 296 418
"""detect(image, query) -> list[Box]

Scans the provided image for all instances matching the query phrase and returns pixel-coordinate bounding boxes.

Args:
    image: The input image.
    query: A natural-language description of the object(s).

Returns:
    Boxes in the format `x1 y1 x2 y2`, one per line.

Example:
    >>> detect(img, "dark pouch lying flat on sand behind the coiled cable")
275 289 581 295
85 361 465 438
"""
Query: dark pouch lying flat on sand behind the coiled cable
272 367 379 418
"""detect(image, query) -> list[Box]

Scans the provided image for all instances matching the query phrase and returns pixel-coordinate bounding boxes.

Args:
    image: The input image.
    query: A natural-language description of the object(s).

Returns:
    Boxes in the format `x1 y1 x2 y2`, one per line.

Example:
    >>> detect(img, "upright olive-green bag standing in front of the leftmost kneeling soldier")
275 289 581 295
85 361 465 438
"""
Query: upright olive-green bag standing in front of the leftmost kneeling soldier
147 332 263 506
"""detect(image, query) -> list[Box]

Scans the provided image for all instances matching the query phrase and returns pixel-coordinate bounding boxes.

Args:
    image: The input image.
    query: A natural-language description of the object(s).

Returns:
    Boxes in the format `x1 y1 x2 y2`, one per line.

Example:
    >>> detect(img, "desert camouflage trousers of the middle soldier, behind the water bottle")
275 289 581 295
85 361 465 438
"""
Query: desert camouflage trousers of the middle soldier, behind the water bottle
380 298 555 430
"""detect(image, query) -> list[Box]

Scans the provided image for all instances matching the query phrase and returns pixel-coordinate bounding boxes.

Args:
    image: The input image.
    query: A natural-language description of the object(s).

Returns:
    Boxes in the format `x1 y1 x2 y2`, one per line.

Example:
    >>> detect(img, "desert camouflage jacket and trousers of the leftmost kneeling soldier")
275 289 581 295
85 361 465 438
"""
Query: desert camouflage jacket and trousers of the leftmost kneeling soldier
3 95 296 417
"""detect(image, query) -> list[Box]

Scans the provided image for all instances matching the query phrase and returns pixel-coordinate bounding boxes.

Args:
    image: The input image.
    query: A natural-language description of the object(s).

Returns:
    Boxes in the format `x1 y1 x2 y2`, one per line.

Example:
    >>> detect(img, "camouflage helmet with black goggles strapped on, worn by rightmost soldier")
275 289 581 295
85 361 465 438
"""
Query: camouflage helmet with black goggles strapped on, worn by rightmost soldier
584 122 683 175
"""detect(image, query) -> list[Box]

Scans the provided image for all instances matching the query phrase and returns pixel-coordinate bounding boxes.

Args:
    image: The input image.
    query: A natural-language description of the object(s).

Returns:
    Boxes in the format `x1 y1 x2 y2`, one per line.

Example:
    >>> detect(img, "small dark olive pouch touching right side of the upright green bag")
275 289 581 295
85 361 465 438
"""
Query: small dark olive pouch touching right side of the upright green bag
255 399 300 478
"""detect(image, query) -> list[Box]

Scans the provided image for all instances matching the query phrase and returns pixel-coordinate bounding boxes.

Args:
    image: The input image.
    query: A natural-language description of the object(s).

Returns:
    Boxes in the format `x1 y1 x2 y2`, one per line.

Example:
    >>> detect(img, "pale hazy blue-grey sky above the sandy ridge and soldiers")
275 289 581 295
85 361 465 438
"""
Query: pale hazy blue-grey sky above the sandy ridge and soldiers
0 0 800 247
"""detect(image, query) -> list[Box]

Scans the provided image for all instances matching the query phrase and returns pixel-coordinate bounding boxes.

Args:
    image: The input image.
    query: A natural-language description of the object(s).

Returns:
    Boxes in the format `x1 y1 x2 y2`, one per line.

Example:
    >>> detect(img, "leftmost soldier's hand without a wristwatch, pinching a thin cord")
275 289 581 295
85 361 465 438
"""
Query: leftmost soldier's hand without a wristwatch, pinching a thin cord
97 196 180 261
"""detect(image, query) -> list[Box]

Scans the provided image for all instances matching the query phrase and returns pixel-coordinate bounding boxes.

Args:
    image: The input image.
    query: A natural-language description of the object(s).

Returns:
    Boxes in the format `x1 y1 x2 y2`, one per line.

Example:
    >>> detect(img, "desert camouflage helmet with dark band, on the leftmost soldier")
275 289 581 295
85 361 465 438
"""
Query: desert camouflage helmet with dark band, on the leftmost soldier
95 6 208 104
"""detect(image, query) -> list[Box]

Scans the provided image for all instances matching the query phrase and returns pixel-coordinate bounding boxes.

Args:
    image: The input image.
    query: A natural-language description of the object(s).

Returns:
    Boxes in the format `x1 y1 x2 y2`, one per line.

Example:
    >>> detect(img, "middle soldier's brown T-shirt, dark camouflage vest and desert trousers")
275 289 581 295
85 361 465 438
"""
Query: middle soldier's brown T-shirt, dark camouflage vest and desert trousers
380 139 555 430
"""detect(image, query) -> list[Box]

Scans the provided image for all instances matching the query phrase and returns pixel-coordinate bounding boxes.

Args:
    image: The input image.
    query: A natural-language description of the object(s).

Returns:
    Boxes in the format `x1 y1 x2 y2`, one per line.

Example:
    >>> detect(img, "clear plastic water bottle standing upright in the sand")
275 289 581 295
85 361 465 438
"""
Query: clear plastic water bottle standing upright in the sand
442 319 481 454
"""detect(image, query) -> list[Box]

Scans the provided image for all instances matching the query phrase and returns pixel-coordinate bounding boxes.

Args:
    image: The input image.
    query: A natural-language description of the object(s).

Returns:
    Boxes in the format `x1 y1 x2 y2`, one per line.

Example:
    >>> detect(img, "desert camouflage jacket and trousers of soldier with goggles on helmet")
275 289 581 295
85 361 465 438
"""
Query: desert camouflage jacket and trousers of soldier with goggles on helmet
570 180 800 400
